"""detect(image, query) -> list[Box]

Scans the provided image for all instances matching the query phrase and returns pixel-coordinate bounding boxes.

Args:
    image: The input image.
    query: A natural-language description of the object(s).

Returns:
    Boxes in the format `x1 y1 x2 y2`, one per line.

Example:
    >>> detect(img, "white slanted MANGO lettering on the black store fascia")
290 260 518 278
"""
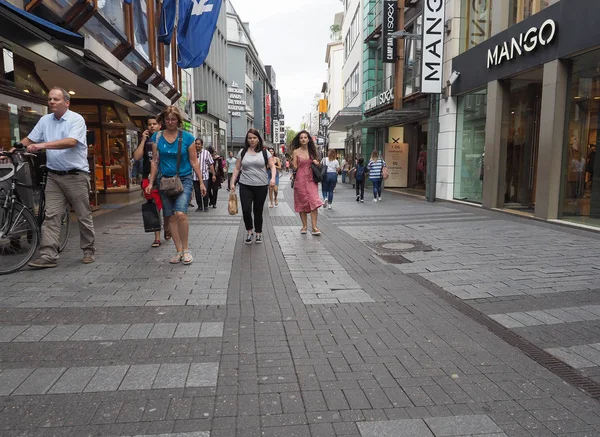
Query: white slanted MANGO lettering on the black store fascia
487 19 557 69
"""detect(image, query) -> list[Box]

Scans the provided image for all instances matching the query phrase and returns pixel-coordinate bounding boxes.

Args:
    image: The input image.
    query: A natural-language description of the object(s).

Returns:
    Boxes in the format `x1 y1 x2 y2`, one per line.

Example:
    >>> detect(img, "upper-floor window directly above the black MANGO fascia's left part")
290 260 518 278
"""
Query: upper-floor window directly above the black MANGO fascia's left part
460 0 494 53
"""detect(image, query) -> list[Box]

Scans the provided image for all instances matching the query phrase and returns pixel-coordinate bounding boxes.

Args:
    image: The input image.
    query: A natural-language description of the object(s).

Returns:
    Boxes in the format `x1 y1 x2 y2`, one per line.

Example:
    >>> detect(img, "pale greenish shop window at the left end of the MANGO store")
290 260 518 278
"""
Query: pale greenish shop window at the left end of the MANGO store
454 90 487 203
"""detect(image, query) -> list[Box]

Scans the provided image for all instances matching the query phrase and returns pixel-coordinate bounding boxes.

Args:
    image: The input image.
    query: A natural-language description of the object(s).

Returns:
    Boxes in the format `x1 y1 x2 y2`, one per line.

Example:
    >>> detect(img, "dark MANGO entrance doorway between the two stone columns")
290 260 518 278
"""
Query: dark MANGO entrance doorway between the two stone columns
503 69 543 209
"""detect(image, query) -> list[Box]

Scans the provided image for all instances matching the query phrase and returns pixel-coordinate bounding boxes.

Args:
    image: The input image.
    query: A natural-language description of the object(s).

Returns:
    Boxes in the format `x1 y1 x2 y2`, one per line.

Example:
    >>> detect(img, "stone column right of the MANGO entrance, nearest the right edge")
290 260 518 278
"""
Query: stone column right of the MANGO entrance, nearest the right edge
535 59 569 219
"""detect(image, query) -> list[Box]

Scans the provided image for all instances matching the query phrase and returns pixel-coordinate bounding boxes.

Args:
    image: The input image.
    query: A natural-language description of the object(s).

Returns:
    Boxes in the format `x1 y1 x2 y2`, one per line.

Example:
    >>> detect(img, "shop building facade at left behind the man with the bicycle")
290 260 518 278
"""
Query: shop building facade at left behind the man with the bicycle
0 0 190 206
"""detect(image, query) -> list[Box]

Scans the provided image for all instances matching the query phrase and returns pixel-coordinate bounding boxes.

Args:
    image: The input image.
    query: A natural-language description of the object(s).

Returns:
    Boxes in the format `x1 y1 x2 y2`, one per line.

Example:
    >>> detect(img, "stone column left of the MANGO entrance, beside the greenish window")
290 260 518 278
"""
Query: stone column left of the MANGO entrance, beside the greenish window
482 80 509 208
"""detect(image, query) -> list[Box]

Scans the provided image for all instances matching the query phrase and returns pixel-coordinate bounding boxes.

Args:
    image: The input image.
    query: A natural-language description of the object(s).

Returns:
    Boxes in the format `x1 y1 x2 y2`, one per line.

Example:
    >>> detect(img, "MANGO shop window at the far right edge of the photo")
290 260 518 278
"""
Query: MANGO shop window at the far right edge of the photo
560 50 600 226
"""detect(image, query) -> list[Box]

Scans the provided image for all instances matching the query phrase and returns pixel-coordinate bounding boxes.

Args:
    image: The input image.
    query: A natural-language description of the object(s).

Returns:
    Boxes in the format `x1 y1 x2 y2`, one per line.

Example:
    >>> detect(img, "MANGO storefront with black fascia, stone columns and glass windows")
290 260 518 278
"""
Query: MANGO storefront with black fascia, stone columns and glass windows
452 0 600 227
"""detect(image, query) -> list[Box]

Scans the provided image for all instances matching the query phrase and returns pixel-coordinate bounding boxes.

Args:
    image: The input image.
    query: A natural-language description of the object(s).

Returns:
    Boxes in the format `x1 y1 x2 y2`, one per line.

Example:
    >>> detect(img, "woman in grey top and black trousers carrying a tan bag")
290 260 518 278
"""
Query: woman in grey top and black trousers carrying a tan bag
231 129 275 244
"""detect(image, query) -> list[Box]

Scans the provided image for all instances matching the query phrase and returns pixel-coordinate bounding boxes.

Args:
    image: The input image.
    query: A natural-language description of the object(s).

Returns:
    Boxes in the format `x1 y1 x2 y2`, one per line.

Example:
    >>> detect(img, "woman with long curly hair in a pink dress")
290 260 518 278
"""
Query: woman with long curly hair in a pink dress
292 130 323 235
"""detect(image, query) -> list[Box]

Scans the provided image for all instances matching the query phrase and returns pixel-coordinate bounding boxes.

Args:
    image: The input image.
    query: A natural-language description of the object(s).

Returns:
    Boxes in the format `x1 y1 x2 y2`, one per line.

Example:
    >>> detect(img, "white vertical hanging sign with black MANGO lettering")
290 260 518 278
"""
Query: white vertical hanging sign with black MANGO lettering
421 0 446 94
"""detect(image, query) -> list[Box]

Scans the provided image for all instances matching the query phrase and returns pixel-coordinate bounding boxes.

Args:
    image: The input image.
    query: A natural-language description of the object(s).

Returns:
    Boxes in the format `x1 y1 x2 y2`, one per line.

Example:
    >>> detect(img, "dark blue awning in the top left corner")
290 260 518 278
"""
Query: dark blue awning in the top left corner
0 0 84 47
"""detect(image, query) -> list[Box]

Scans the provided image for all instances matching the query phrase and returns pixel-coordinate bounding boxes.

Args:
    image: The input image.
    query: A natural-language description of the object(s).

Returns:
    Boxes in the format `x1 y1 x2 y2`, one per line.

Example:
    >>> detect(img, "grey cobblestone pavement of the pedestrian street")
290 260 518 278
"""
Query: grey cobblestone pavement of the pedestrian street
0 177 600 437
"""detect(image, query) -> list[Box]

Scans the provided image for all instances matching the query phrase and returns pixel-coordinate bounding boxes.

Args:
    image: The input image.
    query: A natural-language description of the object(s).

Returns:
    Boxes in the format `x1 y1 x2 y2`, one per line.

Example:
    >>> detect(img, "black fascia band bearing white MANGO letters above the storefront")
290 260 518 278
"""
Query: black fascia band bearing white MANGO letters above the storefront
452 0 600 95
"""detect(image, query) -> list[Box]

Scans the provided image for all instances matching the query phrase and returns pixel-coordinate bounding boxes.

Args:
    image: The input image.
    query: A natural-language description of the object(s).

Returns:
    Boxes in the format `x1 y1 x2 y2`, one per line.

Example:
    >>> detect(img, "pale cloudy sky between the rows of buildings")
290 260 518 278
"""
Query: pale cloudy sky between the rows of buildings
231 0 343 130
